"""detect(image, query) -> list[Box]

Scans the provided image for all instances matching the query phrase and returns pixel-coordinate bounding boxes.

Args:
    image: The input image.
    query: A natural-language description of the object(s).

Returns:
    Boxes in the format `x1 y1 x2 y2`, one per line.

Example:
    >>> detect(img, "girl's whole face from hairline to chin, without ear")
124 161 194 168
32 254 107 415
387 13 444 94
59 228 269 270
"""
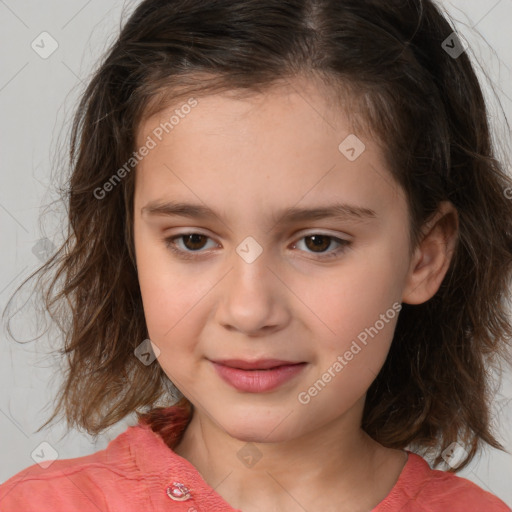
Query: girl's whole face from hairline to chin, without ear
134 77 410 442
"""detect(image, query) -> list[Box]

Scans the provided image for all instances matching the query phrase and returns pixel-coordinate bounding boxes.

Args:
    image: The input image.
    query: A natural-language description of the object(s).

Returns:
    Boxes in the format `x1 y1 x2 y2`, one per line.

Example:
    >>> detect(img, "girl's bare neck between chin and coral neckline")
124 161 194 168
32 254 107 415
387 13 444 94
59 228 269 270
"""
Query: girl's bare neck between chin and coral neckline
174 400 405 512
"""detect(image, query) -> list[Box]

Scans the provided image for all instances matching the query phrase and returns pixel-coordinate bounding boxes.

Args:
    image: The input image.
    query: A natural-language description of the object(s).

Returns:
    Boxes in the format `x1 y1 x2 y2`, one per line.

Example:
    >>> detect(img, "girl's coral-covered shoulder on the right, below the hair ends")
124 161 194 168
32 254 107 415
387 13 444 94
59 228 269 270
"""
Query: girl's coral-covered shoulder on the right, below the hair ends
377 452 511 512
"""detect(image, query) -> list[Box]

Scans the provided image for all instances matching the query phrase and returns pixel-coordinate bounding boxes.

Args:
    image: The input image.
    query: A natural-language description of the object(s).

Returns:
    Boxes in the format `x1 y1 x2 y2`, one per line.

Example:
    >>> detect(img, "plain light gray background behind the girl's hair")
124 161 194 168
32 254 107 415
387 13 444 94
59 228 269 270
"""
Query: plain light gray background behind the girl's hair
0 0 512 506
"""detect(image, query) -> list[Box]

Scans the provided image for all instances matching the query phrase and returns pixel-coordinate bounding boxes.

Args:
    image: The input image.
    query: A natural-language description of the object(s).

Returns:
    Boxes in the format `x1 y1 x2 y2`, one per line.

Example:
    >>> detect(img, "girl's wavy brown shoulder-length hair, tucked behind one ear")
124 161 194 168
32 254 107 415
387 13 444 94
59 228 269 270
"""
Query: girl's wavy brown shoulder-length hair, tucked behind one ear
4 0 512 469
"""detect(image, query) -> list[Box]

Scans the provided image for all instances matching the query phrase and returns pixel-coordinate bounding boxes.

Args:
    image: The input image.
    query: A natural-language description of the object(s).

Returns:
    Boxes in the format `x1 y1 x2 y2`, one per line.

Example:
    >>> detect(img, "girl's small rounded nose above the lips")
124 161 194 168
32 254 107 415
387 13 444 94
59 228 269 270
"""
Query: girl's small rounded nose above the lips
216 246 291 336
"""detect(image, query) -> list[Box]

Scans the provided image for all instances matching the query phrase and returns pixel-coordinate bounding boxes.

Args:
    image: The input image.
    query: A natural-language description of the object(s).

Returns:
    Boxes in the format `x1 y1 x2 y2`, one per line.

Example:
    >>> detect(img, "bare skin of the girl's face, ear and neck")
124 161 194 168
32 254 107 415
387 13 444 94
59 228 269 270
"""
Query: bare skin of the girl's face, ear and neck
134 79 457 512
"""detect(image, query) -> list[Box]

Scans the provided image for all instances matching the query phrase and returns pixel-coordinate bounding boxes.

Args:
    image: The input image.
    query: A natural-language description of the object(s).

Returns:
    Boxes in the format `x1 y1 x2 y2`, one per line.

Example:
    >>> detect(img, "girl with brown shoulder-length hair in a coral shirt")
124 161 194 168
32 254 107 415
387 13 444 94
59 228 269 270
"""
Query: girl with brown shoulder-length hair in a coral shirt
0 0 512 512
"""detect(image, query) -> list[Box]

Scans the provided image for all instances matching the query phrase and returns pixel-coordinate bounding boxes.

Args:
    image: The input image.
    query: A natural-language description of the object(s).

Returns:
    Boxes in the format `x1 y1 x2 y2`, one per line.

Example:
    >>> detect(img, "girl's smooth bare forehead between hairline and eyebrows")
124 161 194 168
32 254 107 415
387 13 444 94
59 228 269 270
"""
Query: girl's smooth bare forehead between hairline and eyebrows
132 77 399 226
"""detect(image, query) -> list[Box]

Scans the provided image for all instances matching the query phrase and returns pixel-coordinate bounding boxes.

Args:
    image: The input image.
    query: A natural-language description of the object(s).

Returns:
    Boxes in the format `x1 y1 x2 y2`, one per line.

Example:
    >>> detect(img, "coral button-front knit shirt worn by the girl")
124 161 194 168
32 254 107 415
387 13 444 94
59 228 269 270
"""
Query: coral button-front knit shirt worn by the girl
0 423 511 512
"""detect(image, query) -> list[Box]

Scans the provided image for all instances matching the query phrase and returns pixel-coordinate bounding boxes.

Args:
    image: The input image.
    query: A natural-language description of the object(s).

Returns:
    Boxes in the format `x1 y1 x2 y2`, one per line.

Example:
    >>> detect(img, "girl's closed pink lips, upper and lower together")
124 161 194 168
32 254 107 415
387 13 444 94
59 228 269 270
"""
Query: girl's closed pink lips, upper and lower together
211 359 306 393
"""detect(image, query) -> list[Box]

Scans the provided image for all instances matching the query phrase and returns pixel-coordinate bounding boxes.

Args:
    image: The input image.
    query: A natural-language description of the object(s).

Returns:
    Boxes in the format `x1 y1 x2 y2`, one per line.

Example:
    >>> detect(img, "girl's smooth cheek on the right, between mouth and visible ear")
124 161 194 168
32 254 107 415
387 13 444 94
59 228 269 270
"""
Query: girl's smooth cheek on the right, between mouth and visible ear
292 240 407 404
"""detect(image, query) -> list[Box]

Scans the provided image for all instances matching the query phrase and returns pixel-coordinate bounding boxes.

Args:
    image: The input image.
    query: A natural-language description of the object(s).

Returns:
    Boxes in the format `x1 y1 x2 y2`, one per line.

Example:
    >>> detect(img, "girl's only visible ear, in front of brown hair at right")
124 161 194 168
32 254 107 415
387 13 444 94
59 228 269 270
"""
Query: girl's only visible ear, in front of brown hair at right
402 201 459 304
